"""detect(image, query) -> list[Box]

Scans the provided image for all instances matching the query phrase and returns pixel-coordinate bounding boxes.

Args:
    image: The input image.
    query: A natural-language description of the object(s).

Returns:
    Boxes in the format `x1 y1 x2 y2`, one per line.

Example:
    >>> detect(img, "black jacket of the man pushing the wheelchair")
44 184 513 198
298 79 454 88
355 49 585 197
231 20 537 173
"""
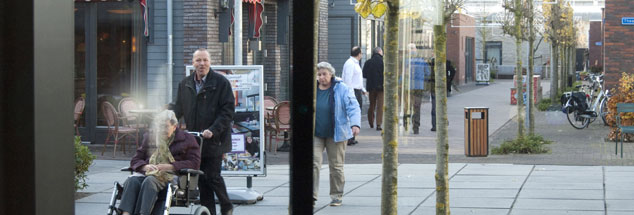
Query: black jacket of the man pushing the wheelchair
172 70 235 158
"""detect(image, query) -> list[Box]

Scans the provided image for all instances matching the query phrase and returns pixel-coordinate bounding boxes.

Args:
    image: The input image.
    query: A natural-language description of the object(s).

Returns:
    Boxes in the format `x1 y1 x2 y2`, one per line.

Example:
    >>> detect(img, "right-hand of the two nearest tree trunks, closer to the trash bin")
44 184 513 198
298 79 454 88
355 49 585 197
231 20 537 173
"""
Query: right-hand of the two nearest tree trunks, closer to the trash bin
434 22 450 215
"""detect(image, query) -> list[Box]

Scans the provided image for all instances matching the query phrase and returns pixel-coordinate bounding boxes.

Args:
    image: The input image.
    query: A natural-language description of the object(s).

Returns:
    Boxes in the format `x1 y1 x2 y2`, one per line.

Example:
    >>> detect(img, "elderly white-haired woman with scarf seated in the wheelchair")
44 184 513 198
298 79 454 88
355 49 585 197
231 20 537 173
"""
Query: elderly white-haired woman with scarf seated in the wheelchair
109 110 206 215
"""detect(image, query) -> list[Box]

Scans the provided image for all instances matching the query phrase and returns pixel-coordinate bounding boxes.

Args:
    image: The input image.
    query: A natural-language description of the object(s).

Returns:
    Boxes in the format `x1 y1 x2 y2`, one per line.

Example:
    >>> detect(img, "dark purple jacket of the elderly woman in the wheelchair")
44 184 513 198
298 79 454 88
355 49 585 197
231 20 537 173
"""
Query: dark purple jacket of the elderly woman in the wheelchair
130 129 200 173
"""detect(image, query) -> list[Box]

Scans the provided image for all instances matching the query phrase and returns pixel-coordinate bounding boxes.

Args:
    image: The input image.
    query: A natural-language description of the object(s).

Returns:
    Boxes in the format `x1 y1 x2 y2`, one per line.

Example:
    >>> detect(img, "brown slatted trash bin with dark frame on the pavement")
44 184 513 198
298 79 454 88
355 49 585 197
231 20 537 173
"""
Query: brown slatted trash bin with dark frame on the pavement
464 107 489 157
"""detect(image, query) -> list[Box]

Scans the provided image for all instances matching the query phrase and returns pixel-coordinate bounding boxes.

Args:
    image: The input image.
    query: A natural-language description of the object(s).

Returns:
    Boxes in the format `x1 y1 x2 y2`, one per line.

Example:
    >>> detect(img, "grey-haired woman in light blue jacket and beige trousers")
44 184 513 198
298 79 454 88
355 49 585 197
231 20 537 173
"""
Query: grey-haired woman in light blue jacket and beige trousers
313 62 361 206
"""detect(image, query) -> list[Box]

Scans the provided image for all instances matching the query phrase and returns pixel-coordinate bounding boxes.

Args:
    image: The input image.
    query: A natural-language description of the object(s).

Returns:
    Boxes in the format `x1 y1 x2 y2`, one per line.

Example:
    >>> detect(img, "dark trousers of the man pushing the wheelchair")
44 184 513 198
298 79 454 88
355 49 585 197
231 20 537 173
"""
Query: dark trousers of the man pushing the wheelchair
198 144 233 215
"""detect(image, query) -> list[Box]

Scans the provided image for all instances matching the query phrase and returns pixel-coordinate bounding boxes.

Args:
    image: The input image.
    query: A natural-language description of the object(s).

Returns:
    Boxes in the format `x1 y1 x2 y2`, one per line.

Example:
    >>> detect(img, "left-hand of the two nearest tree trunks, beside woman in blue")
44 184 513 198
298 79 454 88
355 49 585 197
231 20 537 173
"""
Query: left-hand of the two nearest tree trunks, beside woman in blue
377 0 399 215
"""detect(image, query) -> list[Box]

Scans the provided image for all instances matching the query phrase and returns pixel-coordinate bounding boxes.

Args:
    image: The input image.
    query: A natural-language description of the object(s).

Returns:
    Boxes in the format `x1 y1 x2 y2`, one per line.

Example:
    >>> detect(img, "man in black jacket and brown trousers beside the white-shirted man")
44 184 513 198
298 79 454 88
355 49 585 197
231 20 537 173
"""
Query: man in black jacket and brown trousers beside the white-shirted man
359 47 383 131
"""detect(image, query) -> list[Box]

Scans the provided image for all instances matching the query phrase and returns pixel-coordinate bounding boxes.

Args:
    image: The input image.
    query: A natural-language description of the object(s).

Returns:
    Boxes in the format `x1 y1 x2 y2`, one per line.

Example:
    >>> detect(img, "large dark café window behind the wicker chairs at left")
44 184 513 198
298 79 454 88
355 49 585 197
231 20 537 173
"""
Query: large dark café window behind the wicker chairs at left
75 1 144 126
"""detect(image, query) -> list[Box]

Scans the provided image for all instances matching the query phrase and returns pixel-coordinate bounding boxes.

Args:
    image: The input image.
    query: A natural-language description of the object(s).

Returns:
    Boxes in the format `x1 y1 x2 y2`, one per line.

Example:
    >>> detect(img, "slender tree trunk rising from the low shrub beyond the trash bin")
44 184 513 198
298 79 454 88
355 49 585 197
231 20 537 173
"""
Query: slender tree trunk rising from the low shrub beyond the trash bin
526 0 539 135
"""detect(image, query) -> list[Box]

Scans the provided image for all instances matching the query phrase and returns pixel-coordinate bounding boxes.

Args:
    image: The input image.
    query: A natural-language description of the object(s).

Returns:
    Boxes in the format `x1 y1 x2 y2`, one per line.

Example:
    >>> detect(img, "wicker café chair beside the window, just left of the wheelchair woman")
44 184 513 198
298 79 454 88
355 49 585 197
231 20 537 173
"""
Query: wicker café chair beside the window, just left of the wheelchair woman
101 102 139 157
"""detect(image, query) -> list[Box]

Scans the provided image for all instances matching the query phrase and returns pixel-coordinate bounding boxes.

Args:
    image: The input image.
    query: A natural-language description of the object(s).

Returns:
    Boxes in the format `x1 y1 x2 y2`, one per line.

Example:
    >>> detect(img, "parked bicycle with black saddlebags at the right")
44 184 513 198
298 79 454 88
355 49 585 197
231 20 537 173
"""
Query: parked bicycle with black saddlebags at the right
561 75 609 129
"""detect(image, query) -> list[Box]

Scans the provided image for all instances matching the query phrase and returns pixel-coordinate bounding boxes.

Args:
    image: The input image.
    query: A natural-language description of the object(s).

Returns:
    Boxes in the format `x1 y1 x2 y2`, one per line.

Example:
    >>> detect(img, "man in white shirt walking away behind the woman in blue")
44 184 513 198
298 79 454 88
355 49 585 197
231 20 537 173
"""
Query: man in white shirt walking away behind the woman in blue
341 46 366 145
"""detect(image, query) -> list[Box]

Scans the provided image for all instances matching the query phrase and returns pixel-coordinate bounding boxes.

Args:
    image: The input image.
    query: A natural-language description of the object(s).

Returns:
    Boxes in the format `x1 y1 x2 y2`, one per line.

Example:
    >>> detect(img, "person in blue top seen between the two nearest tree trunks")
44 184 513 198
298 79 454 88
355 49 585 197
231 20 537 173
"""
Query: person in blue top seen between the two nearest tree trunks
409 43 431 134
